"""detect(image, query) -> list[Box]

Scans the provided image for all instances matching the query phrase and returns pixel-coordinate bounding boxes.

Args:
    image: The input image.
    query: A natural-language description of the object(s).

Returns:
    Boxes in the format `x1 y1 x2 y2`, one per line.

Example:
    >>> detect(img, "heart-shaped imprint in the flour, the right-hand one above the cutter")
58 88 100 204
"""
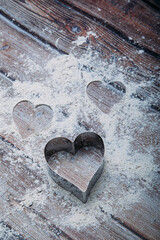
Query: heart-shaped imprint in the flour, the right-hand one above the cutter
87 81 126 113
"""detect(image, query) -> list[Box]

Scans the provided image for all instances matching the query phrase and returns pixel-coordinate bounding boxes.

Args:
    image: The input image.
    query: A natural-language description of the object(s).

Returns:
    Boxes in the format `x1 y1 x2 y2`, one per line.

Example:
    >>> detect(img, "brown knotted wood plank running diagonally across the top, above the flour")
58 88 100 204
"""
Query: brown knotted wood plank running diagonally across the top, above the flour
1 0 159 82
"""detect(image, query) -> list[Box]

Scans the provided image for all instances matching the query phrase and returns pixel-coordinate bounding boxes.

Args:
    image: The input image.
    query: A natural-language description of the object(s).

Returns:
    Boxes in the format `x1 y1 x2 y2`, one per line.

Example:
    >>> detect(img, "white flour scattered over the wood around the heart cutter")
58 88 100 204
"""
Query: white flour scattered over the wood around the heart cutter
0 45 158 229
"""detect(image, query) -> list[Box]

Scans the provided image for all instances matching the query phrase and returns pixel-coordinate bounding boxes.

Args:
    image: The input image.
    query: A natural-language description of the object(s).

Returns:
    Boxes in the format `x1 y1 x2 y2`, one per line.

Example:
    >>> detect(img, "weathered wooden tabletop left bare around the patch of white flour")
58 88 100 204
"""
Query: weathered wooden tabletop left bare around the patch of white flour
0 0 160 240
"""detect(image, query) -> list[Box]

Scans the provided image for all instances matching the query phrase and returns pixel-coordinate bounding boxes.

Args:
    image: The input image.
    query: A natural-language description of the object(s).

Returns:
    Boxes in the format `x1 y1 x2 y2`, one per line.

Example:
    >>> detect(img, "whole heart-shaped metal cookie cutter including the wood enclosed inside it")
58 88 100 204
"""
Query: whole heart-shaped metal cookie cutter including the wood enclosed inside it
44 132 104 203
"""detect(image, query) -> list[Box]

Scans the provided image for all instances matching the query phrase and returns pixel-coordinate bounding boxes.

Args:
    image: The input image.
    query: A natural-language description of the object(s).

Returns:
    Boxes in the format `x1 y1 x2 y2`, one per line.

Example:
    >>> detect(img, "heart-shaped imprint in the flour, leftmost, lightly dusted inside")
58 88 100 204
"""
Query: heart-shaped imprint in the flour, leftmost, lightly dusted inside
13 101 53 138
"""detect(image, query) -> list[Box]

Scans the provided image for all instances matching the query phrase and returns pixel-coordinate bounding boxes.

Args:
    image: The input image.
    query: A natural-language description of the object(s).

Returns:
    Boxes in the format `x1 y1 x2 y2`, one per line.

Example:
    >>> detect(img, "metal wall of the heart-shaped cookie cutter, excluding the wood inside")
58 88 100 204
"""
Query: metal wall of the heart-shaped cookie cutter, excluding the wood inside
44 132 104 203
